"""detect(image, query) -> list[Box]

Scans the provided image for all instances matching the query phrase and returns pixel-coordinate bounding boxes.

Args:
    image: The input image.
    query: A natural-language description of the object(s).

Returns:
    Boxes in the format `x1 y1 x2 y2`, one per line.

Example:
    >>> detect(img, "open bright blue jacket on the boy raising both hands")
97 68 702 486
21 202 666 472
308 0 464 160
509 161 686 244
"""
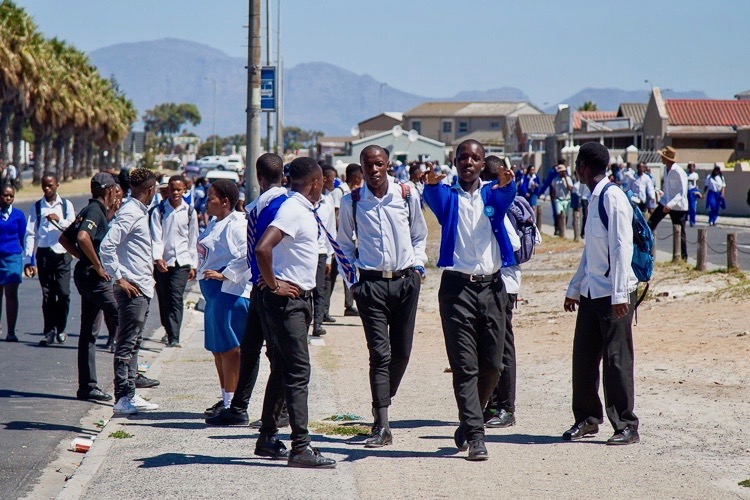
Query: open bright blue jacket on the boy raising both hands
424 181 516 267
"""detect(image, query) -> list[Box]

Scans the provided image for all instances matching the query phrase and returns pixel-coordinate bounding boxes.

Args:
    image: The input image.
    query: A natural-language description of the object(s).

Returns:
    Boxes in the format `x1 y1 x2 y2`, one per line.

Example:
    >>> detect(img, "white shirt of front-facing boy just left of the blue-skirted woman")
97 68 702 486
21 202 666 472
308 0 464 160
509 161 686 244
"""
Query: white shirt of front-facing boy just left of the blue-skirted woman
151 200 198 269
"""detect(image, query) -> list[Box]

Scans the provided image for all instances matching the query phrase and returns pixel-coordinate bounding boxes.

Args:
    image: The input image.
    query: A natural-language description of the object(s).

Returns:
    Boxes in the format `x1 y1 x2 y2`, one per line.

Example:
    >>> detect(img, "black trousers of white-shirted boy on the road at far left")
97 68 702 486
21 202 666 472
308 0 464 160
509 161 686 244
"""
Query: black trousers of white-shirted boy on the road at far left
36 247 73 334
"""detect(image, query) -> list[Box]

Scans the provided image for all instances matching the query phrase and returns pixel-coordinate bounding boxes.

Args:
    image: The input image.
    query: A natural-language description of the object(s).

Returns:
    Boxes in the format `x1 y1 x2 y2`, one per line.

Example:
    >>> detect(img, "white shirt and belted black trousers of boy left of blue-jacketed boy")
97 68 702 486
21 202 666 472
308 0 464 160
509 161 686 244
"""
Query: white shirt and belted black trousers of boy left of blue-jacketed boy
337 178 427 409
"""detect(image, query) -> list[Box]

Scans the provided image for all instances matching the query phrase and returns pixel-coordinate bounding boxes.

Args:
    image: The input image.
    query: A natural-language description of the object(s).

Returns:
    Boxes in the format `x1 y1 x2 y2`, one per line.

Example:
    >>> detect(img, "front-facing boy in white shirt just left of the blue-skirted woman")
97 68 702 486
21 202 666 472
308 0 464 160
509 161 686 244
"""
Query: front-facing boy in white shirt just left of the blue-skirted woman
149 175 198 347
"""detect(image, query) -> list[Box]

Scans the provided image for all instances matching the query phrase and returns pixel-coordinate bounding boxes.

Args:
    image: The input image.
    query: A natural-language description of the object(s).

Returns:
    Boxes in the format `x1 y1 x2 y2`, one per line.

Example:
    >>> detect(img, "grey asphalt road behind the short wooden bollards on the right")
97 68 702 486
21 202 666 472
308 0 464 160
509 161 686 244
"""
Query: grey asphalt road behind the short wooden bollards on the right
540 200 750 271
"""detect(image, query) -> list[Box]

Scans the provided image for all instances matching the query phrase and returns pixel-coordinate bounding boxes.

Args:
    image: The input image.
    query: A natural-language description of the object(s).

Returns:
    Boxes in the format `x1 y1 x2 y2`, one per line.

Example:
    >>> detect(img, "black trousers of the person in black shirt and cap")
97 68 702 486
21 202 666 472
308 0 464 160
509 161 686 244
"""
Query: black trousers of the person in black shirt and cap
73 269 118 394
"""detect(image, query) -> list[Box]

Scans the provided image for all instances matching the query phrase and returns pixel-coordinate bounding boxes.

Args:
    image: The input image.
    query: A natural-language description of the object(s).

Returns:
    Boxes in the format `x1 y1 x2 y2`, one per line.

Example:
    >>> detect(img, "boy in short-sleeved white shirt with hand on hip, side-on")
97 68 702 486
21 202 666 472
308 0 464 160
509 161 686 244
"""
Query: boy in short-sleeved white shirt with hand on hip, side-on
255 157 336 468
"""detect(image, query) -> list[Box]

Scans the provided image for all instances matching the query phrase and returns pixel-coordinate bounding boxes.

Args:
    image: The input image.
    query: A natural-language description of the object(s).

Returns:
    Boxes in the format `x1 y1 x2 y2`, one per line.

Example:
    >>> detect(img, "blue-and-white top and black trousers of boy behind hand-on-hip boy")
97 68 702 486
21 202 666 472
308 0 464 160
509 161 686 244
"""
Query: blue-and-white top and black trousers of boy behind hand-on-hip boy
231 186 287 421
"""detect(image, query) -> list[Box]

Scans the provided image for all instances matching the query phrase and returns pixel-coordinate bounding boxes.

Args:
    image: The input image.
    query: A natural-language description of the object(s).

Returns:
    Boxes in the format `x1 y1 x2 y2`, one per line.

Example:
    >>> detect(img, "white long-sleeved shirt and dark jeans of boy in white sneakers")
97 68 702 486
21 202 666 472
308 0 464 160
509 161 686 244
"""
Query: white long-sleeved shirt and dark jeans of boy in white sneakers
99 198 154 401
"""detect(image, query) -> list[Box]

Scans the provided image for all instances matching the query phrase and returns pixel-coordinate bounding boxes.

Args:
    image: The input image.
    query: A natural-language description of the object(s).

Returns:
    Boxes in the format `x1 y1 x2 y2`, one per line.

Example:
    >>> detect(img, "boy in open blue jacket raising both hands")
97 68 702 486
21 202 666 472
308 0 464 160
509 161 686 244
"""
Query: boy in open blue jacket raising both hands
424 140 516 460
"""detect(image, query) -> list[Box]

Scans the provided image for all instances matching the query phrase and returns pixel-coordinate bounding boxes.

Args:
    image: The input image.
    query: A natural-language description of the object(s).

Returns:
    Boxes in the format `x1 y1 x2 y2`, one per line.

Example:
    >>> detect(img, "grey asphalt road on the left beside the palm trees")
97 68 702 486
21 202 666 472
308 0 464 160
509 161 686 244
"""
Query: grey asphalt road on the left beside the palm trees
0 197 159 499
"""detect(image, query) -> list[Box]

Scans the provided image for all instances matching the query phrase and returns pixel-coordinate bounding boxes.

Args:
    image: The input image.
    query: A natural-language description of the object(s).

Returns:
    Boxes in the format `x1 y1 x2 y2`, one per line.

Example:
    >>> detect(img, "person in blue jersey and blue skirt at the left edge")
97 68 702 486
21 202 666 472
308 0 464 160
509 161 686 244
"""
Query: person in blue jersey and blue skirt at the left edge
0 185 26 342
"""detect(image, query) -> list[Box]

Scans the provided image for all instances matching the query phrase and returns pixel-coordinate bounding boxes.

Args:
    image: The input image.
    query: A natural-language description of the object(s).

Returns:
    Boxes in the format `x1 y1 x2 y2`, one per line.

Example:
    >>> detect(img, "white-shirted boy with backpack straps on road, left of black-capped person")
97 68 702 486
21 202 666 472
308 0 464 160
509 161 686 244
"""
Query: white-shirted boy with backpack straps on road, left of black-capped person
24 173 76 346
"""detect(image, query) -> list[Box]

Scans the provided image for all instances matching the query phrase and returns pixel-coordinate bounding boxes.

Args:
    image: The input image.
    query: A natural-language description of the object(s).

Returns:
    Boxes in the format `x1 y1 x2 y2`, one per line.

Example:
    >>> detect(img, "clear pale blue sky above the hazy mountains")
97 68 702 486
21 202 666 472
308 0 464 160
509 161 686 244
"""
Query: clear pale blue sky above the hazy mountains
17 0 750 105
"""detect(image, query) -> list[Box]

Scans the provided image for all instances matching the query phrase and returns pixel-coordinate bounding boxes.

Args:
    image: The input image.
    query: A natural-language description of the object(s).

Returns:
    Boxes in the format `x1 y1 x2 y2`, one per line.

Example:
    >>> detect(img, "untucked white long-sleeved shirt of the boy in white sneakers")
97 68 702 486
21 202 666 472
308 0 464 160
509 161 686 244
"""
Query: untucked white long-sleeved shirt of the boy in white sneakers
99 198 155 298
